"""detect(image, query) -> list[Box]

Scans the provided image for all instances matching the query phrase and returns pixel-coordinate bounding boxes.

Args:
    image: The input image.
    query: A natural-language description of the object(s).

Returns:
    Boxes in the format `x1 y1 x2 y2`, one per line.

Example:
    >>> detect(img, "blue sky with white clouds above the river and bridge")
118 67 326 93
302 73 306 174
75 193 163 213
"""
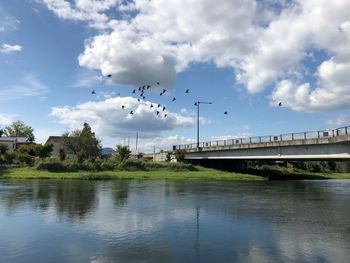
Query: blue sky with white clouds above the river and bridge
0 0 350 152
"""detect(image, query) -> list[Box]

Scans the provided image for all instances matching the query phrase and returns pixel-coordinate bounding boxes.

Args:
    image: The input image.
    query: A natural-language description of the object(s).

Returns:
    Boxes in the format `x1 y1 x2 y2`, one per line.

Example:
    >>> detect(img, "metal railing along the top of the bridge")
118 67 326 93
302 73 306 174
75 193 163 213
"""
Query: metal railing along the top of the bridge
173 126 350 150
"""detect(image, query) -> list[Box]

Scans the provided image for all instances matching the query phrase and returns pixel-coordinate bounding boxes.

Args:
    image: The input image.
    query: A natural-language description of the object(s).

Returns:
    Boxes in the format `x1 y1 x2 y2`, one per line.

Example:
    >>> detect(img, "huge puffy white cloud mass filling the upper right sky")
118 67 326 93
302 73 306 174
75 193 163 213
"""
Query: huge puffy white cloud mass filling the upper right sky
42 0 350 111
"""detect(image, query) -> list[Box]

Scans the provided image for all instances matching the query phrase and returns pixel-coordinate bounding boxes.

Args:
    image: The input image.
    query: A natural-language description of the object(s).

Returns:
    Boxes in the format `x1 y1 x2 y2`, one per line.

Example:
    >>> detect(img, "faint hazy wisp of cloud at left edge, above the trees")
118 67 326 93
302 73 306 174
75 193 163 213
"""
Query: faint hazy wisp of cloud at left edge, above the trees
0 74 49 101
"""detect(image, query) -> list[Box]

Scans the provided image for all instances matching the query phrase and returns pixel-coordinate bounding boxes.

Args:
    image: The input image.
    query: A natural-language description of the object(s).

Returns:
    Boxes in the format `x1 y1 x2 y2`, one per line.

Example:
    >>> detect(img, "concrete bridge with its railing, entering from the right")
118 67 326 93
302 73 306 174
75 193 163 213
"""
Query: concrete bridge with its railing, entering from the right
173 126 350 160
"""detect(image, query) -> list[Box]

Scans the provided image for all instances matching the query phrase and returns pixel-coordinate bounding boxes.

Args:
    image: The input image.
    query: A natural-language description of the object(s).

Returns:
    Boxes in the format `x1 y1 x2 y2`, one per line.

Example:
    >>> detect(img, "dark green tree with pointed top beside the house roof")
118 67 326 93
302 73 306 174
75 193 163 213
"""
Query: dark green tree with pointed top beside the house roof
62 123 101 159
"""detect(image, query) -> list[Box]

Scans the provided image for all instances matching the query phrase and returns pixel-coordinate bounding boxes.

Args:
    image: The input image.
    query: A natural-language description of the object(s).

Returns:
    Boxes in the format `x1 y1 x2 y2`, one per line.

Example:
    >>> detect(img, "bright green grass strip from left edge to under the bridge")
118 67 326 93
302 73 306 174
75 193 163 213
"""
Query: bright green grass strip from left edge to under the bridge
0 167 265 180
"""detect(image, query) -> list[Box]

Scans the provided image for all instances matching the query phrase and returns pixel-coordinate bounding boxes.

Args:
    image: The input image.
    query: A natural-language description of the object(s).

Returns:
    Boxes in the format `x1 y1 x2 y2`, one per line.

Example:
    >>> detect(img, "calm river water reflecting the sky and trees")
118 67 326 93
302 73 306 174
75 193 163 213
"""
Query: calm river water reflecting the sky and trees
0 180 350 262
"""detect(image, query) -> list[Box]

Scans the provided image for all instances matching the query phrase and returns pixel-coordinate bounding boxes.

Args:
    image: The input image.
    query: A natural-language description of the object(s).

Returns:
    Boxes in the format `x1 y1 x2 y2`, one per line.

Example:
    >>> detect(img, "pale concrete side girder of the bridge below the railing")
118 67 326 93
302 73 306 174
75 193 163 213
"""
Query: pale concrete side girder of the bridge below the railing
185 140 350 160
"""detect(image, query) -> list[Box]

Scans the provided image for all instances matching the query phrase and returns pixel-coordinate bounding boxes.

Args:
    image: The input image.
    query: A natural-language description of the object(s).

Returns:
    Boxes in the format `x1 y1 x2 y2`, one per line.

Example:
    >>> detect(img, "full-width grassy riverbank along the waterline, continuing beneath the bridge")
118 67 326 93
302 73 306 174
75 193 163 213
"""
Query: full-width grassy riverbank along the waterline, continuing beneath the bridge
0 167 350 181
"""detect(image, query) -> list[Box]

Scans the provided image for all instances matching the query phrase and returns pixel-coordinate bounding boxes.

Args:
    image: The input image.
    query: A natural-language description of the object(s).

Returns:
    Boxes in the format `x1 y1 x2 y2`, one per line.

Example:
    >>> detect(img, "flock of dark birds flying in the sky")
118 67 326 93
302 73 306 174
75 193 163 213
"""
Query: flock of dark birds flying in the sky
91 74 282 118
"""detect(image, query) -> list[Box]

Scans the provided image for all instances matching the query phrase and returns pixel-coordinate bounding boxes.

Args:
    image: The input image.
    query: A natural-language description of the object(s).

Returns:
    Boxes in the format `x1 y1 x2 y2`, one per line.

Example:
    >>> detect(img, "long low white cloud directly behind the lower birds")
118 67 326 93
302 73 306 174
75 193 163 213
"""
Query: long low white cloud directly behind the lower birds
51 97 195 138
